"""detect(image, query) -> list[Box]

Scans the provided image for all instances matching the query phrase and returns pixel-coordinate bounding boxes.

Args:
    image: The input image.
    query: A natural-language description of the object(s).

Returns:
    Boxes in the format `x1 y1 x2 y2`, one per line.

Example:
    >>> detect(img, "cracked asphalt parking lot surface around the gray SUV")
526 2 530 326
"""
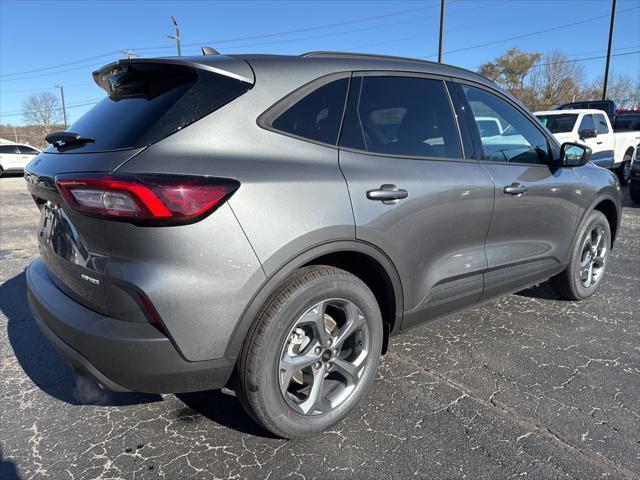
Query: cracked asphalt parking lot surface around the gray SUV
0 177 640 480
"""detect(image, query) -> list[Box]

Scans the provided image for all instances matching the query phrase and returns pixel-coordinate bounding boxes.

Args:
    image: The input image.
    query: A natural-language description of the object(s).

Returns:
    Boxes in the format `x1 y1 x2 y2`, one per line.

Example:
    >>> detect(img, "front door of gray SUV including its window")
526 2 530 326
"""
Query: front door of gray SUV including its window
457 84 580 298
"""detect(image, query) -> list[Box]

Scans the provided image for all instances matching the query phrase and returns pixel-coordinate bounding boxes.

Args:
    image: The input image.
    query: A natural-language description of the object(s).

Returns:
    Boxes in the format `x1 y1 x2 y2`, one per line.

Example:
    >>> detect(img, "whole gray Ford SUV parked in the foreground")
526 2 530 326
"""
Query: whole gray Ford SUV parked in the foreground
25 52 621 438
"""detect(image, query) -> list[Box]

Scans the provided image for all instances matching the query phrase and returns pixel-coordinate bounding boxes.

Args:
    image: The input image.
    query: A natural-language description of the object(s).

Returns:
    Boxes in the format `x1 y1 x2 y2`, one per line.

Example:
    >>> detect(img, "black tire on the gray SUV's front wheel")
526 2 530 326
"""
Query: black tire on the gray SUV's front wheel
551 210 611 300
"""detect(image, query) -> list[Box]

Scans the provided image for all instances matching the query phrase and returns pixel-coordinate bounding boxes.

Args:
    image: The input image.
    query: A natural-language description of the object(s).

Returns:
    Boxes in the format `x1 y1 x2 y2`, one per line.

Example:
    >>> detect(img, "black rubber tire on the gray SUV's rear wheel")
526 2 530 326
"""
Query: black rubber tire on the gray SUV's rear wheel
236 266 383 438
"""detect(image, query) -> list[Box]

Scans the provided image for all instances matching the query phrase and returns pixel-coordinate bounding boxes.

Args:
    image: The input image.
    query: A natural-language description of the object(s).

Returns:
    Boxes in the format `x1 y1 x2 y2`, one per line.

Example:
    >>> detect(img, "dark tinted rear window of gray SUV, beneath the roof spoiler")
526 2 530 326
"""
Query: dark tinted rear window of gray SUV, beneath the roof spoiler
47 64 251 153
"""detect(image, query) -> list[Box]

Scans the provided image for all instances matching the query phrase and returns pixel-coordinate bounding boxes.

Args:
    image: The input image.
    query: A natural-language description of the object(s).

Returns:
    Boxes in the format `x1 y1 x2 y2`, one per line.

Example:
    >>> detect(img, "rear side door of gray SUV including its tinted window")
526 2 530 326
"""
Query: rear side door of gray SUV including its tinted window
340 72 493 328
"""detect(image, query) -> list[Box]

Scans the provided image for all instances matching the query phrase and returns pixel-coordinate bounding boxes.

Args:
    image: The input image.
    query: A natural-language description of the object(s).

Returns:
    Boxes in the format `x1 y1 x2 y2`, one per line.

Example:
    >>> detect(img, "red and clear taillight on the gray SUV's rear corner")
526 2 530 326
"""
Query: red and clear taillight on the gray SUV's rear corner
56 174 240 225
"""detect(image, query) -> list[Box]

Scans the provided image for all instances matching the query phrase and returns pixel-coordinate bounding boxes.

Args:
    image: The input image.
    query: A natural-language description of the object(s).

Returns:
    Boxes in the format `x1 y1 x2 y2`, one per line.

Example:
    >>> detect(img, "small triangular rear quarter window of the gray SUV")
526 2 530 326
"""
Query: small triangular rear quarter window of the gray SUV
271 78 349 145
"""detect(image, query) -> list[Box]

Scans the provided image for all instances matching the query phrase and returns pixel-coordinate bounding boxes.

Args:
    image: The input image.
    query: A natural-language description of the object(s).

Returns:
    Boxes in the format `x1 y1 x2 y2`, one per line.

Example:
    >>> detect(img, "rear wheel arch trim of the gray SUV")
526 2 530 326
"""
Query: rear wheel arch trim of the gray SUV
225 240 404 359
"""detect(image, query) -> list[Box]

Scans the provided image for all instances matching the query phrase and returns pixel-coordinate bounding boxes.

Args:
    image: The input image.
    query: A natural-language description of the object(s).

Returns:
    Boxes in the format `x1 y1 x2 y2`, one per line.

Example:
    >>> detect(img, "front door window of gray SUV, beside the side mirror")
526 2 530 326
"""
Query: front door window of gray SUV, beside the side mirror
462 85 549 164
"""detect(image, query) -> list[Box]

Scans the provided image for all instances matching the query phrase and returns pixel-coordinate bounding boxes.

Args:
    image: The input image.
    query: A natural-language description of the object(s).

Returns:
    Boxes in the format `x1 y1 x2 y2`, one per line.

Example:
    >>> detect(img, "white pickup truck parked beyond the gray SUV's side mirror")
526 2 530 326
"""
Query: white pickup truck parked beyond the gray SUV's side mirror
534 109 640 184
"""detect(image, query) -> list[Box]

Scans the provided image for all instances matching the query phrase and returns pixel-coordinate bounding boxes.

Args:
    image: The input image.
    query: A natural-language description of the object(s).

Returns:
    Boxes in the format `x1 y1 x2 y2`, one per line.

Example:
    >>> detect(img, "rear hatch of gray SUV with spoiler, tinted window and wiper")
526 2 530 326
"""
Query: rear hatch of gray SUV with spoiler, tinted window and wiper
25 56 254 321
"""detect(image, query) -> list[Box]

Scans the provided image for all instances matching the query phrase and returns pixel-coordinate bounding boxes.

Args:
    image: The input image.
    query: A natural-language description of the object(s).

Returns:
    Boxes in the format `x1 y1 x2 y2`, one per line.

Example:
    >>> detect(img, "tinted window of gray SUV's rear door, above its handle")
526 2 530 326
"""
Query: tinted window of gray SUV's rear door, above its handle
340 76 462 158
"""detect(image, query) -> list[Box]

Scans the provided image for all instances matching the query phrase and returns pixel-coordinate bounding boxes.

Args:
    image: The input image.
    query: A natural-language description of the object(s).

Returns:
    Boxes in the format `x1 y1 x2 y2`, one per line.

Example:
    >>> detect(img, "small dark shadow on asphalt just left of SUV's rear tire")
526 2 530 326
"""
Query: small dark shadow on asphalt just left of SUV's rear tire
176 390 279 438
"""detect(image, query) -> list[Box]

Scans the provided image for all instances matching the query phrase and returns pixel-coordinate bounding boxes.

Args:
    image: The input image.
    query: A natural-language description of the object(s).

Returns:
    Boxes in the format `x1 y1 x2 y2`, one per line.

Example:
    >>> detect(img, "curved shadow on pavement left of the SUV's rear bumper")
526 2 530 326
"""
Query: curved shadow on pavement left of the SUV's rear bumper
0 272 162 406
